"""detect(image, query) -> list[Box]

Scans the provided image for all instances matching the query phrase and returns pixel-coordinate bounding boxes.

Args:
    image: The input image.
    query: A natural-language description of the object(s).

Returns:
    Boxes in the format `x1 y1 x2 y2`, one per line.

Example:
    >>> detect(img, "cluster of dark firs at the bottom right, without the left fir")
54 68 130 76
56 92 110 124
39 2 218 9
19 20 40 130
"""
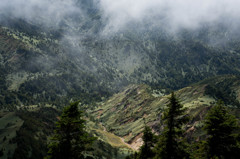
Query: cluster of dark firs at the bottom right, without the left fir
127 93 240 159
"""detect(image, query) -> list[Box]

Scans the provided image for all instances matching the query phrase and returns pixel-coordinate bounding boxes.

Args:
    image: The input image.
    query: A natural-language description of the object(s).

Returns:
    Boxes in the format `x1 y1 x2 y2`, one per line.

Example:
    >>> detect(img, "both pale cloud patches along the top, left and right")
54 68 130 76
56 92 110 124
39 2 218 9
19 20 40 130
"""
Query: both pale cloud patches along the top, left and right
0 0 240 31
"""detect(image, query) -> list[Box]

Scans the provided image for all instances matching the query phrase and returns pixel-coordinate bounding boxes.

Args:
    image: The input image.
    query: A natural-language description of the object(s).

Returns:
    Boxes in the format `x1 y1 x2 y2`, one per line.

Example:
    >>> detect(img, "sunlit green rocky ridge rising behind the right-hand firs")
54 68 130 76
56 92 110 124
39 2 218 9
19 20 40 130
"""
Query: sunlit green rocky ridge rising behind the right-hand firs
93 76 240 148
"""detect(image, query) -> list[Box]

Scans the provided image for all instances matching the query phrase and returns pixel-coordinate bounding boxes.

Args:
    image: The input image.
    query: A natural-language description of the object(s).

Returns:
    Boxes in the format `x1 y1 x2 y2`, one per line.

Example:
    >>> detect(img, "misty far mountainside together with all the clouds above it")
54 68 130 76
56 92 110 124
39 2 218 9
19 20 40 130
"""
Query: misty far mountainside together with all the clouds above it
0 0 240 108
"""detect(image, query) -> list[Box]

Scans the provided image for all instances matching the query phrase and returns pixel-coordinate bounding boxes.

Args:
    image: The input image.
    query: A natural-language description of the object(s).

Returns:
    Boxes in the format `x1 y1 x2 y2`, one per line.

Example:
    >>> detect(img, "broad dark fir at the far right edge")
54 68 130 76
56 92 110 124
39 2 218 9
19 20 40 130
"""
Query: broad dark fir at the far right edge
204 102 240 159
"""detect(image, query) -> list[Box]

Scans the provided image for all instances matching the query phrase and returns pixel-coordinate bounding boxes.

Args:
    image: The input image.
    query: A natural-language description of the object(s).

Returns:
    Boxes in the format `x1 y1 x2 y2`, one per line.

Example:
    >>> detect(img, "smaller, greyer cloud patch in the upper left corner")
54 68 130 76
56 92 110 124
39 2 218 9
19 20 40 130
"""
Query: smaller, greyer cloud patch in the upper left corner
0 0 80 25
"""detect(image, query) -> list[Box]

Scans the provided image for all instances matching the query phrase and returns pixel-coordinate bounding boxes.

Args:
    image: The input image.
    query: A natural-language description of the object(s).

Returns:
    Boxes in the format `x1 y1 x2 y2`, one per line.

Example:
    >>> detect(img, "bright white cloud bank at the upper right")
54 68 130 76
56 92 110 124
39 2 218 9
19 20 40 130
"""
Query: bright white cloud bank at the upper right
100 0 240 31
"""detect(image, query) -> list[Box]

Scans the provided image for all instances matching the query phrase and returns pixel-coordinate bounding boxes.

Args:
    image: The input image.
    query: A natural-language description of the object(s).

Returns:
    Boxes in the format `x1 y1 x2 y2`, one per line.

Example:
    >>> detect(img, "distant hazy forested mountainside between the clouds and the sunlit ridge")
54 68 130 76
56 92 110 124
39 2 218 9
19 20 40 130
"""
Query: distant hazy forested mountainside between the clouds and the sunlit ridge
1 18 240 109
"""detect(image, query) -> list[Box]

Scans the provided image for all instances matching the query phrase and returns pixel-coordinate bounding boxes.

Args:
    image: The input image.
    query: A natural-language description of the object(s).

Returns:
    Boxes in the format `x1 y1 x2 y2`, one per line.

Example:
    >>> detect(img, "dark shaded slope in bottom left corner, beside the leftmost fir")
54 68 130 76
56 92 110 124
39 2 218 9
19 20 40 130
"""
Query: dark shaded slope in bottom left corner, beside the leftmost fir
0 108 58 159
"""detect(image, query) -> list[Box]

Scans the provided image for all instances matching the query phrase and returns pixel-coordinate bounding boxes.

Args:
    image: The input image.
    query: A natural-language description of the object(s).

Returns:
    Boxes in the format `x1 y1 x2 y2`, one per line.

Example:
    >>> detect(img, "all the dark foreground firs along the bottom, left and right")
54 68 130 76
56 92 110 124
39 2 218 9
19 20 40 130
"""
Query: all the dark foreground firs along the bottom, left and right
45 93 240 159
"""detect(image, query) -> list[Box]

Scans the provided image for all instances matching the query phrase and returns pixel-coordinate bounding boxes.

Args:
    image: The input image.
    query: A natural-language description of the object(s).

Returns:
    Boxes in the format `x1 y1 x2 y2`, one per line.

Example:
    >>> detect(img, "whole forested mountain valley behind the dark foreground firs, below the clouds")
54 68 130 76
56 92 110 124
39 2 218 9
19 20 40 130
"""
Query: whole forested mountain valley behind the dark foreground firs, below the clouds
0 0 240 159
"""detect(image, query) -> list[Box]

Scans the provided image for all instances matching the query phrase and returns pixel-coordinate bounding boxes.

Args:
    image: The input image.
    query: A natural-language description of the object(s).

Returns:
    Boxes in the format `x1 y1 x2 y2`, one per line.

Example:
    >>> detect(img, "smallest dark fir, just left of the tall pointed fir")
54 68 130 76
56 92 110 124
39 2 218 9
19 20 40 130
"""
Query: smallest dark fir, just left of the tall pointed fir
138 126 156 159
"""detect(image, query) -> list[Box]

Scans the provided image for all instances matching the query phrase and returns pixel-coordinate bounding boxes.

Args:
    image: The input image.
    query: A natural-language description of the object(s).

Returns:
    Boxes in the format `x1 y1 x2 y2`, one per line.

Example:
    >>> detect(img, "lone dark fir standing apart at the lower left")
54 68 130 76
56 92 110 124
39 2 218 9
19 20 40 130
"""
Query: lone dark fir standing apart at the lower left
46 102 94 159
